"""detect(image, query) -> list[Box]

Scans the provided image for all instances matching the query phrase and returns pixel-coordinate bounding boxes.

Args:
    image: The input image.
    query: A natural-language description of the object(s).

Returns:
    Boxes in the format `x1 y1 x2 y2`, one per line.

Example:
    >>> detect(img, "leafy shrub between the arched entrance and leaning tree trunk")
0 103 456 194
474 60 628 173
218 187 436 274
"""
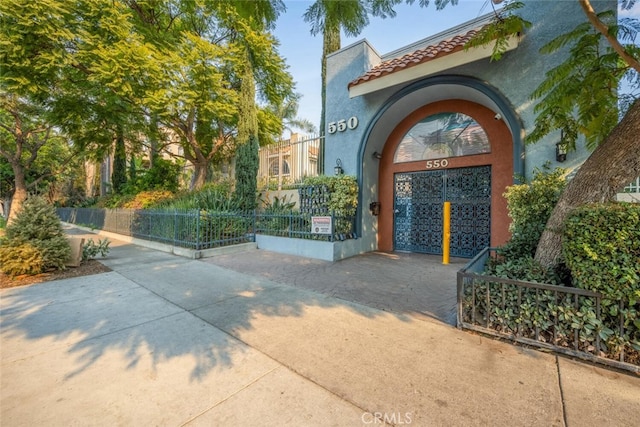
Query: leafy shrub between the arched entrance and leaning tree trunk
500 165 566 260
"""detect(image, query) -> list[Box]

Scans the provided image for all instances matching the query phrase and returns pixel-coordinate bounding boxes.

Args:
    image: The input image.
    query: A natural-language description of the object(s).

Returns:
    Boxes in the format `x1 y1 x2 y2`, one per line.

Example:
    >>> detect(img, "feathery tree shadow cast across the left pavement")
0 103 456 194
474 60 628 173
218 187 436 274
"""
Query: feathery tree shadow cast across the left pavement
0 241 410 381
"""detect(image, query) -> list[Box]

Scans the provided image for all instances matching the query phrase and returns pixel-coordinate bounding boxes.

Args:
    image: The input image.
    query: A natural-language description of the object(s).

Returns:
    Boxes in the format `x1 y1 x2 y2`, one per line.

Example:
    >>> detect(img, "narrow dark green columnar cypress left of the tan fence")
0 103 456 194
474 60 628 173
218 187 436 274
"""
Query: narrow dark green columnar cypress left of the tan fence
234 135 260 211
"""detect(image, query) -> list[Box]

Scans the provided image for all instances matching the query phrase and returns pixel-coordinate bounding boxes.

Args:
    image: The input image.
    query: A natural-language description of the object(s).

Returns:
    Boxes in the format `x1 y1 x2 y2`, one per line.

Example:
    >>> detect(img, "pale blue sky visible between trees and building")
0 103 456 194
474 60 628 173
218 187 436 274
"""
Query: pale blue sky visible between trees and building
273 0 640 135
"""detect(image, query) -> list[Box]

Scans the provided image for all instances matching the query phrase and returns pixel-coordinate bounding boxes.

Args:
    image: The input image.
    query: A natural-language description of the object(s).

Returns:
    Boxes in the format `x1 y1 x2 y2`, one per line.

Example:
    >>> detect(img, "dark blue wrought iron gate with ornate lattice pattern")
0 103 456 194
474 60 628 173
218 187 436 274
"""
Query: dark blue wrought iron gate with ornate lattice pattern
394 166 491 257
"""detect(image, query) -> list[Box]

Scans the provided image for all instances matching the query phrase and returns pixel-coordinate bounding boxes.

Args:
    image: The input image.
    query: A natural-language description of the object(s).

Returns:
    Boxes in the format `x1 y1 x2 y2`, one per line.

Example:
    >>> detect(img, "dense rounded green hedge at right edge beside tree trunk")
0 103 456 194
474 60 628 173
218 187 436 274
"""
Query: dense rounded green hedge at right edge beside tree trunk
562 203 640 362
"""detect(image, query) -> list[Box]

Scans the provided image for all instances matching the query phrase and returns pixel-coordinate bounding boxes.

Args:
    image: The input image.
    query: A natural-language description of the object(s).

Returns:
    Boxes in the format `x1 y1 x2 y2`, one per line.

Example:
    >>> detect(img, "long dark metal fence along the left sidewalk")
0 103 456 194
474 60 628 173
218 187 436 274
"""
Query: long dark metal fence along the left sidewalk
57 208 356 250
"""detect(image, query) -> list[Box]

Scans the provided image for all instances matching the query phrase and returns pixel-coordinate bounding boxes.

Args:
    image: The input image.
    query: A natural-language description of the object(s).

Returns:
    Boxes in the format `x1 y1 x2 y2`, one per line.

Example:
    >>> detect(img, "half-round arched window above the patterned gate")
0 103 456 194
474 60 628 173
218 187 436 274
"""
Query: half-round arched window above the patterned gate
393 113 491 163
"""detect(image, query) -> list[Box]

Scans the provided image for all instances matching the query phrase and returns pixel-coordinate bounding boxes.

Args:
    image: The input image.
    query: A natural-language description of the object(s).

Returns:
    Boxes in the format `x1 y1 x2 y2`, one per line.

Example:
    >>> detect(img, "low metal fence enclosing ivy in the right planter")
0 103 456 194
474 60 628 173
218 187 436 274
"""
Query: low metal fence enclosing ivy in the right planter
457 248 640 373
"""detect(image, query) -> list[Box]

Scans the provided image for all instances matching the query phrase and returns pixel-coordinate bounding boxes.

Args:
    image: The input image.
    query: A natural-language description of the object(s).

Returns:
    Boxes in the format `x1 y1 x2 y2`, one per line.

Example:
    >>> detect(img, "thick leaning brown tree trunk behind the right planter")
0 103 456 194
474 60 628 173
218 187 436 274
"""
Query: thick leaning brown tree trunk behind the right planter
535 101 640 267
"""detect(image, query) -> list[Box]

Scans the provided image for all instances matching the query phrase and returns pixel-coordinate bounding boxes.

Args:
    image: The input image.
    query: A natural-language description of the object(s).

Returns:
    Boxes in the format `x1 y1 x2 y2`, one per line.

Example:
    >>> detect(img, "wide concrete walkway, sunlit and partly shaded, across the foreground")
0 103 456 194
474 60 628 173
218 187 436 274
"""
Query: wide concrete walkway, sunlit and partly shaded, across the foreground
0 232 640 426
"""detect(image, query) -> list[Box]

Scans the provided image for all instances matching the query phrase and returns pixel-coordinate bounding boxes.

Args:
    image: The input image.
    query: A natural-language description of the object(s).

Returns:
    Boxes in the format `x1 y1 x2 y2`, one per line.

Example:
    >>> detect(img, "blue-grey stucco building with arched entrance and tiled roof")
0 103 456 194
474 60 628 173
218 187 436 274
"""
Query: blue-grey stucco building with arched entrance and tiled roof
324 1 616 257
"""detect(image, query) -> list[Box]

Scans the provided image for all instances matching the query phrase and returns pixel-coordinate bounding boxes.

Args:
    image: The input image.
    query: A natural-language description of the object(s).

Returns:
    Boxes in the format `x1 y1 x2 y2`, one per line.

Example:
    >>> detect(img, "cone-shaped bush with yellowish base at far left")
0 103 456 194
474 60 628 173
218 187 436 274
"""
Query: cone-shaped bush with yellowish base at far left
0 197 71 276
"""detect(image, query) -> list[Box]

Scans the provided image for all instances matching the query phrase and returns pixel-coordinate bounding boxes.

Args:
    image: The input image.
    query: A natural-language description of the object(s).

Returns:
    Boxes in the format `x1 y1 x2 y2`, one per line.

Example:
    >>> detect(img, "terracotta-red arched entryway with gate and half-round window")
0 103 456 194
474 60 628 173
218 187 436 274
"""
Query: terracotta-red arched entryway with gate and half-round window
378 99 514 257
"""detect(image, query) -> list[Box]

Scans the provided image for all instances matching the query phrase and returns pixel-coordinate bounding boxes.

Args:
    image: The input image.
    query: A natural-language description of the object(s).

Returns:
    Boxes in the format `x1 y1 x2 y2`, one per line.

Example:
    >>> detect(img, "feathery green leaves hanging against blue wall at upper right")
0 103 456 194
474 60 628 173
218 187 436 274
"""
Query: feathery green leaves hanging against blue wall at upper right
527 11 640 149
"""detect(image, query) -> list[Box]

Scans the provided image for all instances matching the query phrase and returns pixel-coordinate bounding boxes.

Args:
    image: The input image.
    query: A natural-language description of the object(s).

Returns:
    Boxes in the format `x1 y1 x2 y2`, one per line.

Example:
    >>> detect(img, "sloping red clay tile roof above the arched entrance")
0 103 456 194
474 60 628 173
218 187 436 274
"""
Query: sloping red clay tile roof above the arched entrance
348 27 481 88
